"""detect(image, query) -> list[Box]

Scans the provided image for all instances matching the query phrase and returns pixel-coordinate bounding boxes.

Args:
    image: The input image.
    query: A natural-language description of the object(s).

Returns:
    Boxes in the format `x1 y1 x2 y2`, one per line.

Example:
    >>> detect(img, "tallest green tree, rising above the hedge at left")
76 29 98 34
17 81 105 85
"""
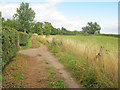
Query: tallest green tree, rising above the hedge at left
14 2 35 33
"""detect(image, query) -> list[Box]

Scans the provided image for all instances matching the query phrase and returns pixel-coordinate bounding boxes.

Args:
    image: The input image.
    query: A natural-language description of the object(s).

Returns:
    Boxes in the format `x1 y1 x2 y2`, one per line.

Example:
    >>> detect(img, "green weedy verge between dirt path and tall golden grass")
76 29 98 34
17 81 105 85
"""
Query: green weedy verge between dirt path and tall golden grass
39 36 118 88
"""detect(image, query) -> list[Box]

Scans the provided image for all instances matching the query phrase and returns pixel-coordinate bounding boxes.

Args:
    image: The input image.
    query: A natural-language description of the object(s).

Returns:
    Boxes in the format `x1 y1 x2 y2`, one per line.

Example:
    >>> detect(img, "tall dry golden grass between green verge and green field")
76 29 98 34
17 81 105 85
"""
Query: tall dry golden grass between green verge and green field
53 38 118 87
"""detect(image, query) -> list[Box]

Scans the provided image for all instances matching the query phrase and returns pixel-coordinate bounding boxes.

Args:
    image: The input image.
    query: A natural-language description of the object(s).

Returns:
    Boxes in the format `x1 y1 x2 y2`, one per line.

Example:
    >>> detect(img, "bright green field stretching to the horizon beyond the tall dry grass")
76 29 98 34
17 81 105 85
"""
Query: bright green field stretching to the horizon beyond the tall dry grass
51 35 118 55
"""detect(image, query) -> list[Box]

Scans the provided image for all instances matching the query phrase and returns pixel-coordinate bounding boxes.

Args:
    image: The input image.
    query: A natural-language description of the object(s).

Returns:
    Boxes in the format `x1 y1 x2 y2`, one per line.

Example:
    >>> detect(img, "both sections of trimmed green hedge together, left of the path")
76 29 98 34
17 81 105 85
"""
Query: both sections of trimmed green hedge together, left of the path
2 27 31 68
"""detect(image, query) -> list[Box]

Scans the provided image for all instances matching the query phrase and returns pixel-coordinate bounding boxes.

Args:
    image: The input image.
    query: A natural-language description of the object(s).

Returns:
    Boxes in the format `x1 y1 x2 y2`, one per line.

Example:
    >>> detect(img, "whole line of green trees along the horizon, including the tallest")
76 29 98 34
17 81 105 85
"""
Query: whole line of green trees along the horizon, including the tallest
2 2 101 35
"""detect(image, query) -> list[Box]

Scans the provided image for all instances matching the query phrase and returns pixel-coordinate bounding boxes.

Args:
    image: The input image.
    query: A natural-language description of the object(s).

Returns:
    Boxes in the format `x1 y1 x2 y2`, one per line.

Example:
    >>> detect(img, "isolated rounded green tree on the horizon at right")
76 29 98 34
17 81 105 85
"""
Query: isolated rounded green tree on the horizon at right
82 22 101 34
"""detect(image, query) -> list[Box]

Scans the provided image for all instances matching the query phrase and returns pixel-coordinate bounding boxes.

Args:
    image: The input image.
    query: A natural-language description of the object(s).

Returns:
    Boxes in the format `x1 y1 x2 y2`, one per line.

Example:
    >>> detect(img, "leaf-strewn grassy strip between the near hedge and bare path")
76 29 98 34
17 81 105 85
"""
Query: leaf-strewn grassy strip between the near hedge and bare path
2 53 28 88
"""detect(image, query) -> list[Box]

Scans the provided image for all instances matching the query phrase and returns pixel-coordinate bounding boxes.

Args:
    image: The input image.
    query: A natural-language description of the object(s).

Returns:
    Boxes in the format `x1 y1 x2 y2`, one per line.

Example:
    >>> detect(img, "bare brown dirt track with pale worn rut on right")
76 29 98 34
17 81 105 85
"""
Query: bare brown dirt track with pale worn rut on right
19 44 82 88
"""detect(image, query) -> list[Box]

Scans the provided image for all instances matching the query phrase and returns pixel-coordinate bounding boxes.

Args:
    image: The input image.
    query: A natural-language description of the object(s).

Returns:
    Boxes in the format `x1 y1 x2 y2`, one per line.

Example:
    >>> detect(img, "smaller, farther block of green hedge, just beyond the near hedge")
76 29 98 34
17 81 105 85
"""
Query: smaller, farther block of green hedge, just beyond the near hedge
19 32 29 46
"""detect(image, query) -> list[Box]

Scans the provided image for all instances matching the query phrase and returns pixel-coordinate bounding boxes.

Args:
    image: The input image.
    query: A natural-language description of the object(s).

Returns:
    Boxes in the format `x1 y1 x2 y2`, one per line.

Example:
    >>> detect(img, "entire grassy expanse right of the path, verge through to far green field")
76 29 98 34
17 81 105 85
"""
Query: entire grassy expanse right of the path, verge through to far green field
40 35 118 88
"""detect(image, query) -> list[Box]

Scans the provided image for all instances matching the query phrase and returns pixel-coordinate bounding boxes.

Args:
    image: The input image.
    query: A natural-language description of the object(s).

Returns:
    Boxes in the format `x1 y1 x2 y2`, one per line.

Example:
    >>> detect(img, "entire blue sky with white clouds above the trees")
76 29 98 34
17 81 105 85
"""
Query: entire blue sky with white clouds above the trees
0 0 118 34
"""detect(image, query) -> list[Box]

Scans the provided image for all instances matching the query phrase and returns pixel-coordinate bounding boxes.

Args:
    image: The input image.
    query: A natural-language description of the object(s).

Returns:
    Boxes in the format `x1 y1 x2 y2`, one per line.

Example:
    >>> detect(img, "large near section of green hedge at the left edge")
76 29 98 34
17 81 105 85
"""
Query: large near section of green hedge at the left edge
2 28 18 68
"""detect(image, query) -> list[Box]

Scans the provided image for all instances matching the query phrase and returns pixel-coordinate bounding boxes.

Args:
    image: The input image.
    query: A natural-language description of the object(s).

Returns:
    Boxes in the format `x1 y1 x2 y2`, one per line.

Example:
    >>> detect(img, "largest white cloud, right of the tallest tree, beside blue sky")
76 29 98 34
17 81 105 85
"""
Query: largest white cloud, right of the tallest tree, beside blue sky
31 0 86 30
